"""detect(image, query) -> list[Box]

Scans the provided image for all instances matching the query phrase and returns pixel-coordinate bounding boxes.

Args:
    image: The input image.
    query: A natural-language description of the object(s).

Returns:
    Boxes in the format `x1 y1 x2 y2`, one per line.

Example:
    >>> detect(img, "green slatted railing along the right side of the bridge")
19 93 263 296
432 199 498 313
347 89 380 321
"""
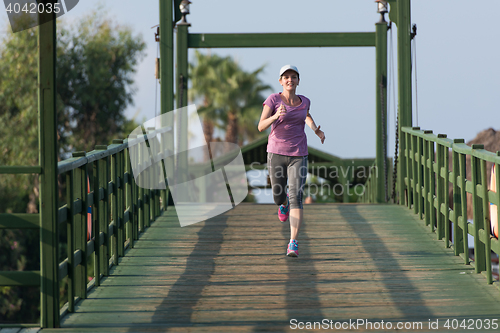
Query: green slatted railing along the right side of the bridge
398 127 500 283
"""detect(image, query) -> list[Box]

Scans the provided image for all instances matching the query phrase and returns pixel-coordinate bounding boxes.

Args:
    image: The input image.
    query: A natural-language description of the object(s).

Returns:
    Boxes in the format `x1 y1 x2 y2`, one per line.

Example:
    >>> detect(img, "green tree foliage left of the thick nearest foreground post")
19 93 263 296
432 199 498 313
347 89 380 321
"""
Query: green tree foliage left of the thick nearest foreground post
0 29 40 322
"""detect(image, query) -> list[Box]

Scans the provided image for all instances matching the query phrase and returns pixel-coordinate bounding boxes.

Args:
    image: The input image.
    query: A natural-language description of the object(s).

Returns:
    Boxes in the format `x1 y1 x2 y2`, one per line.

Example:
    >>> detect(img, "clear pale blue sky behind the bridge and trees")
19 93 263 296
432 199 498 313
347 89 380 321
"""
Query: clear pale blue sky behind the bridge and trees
0 0 500 158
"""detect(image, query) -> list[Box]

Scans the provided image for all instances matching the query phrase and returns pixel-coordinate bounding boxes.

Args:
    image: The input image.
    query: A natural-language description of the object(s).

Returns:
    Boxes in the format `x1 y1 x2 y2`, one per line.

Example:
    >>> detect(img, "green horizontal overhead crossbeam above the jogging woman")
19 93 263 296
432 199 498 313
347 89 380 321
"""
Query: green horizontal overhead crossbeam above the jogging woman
188 32 375 48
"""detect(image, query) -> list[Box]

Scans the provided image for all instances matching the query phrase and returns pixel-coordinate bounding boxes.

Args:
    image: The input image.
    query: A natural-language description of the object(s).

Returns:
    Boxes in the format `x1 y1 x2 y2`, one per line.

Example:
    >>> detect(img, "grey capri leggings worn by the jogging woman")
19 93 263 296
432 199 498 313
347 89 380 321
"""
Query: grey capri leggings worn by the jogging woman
267 153 307 209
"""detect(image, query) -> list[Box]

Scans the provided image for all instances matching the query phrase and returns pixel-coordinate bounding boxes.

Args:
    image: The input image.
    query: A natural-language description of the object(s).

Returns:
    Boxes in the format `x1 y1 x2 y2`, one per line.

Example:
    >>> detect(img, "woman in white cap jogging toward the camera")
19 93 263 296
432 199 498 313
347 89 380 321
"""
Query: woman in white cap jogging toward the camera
258 65 325 257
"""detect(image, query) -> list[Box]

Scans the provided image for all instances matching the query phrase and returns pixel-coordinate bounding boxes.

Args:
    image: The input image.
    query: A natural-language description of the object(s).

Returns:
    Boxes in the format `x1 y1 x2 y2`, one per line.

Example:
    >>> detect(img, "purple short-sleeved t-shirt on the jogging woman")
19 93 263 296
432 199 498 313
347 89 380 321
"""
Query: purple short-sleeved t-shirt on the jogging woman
263 93 311 156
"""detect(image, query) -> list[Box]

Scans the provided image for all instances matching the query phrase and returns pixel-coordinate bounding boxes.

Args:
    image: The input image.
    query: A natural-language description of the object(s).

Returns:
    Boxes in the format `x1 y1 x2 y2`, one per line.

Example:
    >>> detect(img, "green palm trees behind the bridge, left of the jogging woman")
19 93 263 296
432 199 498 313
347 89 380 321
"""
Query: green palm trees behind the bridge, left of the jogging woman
190 52 270 145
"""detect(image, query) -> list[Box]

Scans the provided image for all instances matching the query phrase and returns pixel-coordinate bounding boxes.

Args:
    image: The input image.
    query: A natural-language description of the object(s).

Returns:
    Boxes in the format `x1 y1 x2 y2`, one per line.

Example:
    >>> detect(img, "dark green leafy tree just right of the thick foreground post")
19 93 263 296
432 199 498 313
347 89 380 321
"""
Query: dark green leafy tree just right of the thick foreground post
57 12 145 151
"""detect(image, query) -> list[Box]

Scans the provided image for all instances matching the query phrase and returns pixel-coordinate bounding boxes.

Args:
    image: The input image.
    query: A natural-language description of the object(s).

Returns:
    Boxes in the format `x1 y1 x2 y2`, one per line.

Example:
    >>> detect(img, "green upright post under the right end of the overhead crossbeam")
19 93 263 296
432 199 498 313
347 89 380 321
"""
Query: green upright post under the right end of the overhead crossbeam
375 13 388 203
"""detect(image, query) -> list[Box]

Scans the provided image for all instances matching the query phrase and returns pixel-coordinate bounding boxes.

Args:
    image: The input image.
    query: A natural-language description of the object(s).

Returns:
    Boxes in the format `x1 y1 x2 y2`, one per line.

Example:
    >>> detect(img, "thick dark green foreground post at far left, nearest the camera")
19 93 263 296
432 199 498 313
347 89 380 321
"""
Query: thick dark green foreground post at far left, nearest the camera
38 5 60 328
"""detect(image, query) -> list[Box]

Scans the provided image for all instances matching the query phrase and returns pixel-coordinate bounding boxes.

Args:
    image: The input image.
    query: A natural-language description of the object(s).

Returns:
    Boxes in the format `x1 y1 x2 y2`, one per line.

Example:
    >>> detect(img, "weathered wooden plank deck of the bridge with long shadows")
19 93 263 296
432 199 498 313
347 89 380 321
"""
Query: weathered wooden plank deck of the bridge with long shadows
42 204 500 333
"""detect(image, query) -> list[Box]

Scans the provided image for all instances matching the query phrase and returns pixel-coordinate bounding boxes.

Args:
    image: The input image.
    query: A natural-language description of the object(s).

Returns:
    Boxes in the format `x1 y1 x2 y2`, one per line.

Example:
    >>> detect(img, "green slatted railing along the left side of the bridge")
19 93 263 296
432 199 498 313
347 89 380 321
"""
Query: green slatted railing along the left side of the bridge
0 130 169 328
